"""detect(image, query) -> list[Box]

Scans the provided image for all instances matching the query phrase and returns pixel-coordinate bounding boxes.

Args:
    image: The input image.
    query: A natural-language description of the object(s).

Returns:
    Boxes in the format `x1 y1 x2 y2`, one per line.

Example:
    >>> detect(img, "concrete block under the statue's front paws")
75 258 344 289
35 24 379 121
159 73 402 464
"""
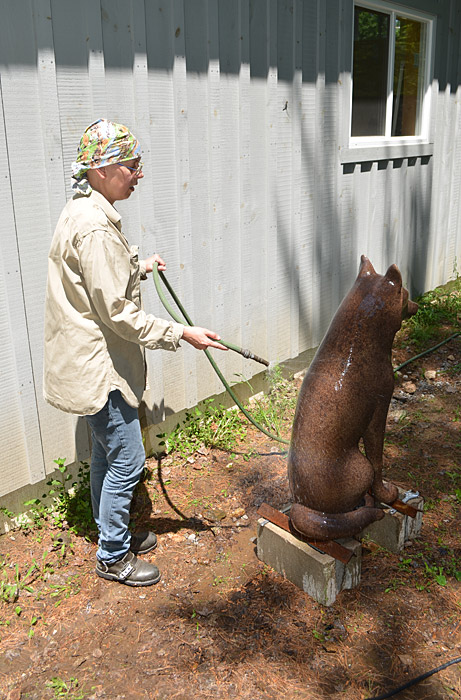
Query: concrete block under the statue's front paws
357 489 424 553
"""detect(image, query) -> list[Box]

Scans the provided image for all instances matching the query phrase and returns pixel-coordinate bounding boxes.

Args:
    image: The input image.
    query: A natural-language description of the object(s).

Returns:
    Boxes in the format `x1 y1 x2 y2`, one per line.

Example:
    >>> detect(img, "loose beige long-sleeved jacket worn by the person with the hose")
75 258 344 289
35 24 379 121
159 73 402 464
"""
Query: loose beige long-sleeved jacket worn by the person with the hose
44 190 184 415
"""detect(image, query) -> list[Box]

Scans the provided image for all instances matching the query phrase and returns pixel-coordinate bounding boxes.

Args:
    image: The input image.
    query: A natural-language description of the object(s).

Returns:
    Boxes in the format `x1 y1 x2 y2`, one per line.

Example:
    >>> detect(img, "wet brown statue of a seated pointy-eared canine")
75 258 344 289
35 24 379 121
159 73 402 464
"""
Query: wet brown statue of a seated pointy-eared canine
288 255 418 540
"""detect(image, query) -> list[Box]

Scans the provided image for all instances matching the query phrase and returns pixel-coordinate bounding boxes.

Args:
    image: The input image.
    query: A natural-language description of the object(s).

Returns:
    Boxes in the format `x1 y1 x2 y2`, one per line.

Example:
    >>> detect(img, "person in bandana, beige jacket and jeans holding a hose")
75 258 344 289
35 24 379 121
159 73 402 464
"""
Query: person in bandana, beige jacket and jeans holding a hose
44 119 226 586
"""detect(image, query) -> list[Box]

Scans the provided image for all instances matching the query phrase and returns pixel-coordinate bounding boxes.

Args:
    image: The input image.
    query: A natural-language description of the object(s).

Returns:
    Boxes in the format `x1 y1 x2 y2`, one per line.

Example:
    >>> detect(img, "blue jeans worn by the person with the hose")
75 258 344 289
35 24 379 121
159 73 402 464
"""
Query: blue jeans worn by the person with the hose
85 390 146 565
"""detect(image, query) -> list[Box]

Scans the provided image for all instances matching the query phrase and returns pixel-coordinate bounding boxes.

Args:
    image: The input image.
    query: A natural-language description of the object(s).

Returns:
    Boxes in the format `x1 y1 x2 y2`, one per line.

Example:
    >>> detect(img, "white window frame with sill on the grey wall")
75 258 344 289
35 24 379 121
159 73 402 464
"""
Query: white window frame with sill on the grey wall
341 0 436 163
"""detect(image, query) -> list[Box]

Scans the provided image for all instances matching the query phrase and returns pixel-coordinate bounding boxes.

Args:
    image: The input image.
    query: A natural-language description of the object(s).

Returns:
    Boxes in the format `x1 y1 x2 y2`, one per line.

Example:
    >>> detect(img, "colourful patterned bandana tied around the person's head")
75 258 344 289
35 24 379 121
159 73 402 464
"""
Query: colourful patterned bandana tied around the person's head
72 119 141 195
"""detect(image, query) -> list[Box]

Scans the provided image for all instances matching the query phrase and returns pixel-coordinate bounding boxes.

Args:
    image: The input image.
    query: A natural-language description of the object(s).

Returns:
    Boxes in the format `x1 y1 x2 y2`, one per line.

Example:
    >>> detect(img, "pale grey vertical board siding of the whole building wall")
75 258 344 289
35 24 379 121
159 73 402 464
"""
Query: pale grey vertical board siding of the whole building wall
0 0 461 493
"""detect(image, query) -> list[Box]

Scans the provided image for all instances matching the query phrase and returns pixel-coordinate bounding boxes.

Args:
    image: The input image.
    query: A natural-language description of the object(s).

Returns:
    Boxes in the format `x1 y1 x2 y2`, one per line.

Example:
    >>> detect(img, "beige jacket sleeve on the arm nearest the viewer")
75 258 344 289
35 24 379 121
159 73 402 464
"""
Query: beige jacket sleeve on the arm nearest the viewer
78 230 184 350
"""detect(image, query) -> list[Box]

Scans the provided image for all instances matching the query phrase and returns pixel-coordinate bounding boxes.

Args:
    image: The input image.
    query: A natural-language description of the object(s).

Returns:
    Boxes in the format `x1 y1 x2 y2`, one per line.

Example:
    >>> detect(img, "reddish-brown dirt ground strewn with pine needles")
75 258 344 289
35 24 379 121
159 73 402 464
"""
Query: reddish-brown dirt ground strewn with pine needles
0 336 461 700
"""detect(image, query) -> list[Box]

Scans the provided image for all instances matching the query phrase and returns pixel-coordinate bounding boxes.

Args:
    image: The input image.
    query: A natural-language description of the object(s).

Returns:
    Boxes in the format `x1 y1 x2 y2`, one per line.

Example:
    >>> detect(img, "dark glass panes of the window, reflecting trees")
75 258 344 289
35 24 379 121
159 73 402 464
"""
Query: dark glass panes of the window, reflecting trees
350 1 433 143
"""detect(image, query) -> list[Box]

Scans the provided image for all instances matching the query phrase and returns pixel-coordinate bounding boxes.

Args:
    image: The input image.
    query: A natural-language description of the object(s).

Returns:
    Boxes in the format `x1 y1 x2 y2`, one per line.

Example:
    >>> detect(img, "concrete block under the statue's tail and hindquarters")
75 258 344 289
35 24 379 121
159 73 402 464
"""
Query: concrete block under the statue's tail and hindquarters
257 518 362 606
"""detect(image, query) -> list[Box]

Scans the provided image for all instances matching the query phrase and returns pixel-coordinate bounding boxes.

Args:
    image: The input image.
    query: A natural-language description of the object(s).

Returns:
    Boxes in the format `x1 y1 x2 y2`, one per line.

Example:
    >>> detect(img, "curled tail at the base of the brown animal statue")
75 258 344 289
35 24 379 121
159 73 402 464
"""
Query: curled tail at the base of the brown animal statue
289 503 384 541
